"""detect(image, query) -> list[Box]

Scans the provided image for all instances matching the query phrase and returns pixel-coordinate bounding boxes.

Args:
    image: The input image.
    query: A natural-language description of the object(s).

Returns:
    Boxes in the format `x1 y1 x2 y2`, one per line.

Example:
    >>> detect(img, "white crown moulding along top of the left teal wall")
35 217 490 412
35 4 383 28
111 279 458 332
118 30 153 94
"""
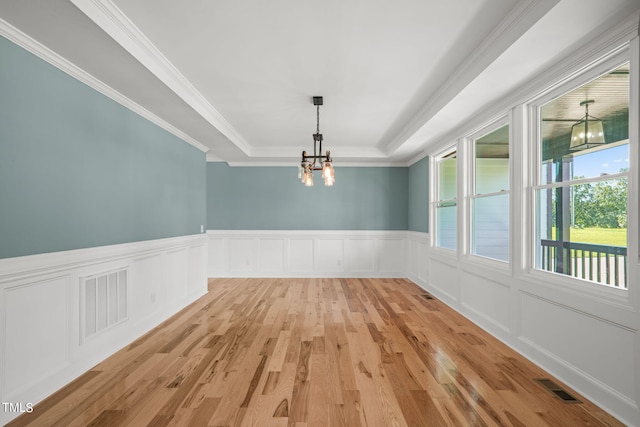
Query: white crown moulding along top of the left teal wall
0 18 209 153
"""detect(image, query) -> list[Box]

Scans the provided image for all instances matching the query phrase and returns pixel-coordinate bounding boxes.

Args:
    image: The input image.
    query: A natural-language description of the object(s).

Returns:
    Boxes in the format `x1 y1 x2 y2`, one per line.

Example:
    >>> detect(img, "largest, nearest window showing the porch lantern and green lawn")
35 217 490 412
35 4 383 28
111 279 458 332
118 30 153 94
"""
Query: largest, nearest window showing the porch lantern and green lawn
535 64 629 289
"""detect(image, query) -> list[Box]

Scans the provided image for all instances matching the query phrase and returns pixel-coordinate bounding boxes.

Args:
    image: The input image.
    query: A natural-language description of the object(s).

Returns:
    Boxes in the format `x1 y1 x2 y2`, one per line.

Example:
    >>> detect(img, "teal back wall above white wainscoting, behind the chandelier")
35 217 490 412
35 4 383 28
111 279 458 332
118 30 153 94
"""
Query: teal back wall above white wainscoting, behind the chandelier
207 163 409 230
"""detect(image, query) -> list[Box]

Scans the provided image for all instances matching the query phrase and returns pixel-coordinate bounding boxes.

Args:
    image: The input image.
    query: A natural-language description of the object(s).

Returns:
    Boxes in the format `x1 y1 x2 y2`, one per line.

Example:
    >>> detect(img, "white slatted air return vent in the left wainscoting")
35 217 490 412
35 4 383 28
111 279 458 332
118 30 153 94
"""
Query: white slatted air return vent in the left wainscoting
80 268 127 341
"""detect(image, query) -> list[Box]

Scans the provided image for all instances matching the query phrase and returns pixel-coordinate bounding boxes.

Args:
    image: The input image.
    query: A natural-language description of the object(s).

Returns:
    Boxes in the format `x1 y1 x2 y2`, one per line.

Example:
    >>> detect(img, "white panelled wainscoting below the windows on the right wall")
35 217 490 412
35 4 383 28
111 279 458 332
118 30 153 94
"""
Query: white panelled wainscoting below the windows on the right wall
422 246 640 426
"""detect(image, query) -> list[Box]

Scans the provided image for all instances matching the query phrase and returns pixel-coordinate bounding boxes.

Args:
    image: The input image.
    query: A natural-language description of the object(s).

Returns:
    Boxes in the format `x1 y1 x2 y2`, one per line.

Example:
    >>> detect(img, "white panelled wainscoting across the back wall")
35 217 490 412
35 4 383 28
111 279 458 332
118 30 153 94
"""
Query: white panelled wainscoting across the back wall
207 230 412 277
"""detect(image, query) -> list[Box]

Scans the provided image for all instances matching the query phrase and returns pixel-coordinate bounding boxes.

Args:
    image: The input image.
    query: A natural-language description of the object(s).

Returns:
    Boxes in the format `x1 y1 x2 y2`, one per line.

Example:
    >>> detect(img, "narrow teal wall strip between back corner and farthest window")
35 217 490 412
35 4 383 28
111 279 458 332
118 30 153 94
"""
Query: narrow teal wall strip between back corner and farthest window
409 157 429 233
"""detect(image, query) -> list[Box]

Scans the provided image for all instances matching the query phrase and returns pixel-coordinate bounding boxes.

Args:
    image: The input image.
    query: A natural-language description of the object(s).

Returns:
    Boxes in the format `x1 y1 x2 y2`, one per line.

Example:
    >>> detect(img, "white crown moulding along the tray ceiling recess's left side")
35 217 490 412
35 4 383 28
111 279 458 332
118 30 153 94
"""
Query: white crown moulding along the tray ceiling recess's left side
71 0 253 156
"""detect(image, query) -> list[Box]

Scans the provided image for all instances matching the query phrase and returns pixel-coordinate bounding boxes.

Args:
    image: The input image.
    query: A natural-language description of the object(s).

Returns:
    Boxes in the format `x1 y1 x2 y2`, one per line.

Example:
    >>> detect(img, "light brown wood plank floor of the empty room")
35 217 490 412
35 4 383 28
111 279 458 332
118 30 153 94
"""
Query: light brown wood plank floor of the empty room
9 279 622 427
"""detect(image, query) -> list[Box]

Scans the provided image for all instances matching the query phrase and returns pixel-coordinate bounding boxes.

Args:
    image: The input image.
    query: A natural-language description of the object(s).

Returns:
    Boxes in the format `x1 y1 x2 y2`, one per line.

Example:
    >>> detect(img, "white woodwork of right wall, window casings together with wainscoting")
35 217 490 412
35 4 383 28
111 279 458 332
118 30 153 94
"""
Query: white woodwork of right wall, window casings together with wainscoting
416 13 640 425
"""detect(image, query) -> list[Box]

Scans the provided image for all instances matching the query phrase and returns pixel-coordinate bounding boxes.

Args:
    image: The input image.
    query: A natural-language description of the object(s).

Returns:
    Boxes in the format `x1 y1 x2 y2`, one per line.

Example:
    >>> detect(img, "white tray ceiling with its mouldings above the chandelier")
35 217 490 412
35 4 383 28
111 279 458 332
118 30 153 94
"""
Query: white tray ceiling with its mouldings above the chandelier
0 0 640 166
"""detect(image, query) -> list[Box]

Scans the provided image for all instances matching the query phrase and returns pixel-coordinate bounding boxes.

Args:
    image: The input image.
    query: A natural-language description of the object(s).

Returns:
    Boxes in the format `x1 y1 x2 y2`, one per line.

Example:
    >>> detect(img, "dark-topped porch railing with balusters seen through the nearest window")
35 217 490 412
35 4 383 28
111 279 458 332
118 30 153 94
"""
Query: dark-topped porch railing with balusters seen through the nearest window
540 240 627 289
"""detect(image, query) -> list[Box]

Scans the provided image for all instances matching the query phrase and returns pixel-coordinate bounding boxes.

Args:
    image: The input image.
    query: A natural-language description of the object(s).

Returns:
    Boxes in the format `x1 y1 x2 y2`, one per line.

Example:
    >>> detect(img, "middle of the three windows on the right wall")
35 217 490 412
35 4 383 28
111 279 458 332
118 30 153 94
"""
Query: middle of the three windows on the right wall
470 125 509 261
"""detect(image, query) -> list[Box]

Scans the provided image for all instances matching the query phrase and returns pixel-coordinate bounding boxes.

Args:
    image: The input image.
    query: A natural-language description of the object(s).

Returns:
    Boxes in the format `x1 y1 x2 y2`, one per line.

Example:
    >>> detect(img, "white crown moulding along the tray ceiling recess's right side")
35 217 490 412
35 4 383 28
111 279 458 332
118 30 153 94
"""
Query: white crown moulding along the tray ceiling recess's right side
386 0 559 155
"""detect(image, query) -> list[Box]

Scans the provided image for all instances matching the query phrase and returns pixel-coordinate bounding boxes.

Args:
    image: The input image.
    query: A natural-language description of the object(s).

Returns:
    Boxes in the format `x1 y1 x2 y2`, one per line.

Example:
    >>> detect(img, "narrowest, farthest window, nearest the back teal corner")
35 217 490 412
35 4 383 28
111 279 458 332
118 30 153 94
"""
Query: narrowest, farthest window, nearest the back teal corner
435 151 458 250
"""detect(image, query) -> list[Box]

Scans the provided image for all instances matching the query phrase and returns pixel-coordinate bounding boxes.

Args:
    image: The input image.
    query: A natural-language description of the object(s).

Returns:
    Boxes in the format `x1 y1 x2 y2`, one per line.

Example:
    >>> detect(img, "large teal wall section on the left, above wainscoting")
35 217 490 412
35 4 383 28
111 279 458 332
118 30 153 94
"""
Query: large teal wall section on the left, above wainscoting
0 37 206 258
